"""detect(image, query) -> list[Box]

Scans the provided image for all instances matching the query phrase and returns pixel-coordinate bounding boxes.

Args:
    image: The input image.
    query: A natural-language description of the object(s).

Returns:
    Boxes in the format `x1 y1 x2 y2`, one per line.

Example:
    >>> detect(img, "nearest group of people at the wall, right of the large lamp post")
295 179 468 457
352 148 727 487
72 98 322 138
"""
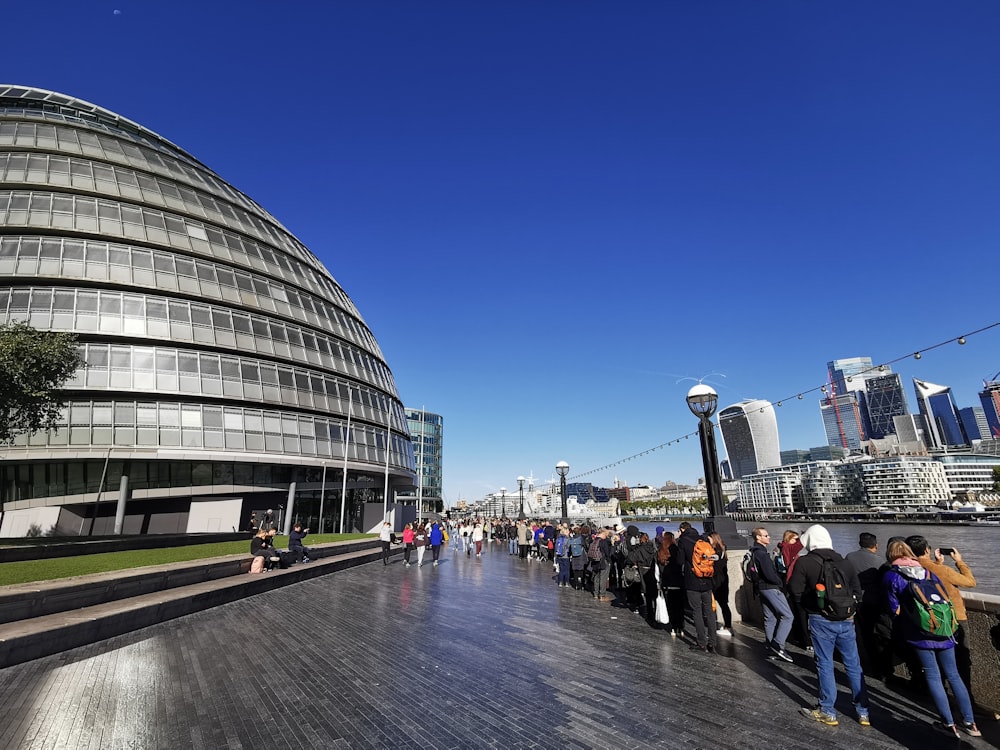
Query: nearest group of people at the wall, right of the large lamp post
745 525 981 737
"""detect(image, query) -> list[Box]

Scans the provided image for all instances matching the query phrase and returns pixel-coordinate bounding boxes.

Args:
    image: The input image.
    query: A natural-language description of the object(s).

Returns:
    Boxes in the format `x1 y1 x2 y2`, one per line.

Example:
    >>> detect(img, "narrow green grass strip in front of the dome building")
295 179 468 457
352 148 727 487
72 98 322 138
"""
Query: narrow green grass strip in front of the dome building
0 534 372 586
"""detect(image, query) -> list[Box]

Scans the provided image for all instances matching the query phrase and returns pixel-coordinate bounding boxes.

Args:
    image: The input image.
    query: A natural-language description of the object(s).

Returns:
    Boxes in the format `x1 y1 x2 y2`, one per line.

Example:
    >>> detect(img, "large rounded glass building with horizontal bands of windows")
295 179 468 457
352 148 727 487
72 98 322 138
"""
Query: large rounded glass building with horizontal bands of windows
0 84 416 536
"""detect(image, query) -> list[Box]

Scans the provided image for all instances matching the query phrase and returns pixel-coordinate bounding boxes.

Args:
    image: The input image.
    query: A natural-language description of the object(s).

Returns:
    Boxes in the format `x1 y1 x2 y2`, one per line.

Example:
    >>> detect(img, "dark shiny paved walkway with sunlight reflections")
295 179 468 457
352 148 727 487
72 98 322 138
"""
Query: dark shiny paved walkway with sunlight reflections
0 546 1000 750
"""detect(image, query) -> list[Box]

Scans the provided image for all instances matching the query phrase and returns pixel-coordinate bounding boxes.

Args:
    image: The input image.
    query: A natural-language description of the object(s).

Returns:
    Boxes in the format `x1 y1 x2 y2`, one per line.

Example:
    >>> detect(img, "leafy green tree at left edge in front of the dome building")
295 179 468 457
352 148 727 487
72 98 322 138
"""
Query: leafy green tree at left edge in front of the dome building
0 323 84 444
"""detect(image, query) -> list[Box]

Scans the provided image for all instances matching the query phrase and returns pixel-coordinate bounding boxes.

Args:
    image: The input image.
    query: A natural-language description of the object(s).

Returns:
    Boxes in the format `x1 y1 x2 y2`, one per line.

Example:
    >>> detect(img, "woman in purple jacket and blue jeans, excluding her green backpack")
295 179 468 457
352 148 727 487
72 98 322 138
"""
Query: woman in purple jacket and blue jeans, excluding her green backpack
882 541 982 738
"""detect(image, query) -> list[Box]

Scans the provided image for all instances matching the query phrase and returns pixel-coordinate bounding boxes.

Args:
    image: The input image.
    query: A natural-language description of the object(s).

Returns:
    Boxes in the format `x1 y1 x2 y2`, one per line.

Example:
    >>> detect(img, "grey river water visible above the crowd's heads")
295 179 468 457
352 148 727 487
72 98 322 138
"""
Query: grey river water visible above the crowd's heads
635 519 1000 596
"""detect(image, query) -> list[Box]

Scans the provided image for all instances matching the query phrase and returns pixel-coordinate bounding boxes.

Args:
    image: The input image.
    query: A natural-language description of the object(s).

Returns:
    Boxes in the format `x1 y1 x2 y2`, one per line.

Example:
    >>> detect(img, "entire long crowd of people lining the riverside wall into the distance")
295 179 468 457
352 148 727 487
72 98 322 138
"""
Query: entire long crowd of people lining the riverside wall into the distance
394 518 981 737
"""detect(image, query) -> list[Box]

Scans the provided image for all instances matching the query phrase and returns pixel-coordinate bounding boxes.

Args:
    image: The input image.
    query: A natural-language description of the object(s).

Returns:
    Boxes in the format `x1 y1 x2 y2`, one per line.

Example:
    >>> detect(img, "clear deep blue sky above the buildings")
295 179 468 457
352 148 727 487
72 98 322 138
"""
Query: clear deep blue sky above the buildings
0 0 1000 503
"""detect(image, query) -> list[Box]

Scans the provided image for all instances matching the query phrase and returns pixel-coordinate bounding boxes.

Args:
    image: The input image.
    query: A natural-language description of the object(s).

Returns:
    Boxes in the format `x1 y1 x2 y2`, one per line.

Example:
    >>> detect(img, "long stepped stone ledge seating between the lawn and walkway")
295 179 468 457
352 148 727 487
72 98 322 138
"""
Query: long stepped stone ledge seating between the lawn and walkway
0 539 402 668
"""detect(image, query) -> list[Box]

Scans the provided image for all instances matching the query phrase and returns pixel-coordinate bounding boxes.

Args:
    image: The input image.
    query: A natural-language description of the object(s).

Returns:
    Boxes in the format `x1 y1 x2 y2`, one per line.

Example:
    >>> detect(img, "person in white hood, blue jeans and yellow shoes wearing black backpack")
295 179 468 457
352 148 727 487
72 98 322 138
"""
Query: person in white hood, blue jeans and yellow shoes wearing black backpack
788 524 871 727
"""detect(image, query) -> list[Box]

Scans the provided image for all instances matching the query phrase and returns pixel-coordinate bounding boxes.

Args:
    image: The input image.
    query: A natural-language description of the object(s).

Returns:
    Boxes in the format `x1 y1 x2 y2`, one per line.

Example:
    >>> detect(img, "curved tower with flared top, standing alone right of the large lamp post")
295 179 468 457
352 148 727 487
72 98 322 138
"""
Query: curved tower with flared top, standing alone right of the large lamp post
719 399 781 479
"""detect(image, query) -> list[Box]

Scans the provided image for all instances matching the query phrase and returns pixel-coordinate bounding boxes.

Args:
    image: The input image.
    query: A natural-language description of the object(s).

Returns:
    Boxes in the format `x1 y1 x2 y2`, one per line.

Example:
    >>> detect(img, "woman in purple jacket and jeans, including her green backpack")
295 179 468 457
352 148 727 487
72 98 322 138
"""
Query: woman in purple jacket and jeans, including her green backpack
882 541 982 737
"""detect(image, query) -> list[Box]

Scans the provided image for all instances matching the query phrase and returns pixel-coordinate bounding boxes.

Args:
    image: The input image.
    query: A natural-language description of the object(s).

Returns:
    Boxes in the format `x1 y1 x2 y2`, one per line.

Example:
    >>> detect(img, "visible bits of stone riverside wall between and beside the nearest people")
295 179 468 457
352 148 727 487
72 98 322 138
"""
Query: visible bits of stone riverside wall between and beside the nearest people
729 551 1000 718
